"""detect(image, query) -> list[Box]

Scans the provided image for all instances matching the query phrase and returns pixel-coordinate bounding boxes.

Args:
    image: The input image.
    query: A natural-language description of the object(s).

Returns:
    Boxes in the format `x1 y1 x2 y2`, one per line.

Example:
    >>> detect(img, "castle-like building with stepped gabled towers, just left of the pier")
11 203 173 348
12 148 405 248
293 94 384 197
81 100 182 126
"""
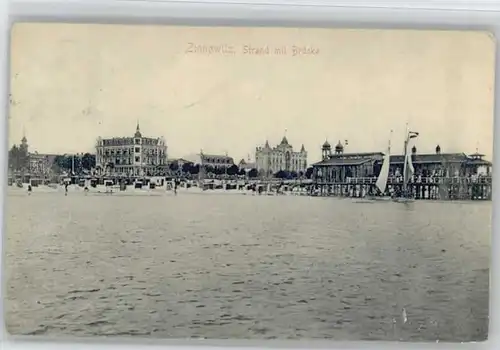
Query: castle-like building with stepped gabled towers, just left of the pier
255 136 307 177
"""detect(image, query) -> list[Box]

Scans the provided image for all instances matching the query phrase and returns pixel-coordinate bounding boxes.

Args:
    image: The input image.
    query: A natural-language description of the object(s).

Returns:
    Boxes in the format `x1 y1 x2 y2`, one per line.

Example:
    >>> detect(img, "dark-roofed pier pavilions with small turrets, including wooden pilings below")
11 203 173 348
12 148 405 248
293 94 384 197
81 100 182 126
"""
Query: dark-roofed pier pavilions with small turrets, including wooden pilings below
312 142 492 199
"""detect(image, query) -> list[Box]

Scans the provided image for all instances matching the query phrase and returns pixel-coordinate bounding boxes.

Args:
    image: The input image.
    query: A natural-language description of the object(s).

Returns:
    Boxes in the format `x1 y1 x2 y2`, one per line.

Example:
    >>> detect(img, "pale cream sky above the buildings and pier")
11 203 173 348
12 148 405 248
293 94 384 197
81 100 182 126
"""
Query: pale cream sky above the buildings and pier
9 23 495 162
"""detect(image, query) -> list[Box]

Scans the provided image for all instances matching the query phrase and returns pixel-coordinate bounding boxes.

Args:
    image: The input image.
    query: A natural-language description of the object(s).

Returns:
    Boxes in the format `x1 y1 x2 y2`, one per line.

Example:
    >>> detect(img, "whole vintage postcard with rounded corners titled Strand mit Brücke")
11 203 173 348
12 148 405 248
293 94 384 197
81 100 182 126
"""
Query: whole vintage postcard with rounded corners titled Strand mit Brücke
3 23 495 342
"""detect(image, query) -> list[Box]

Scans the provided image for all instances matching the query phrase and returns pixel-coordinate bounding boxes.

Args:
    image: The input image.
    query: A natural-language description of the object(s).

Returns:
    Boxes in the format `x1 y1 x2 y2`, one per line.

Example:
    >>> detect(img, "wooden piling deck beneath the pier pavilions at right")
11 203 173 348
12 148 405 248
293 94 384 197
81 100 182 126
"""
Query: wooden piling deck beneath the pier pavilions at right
311 176 492 200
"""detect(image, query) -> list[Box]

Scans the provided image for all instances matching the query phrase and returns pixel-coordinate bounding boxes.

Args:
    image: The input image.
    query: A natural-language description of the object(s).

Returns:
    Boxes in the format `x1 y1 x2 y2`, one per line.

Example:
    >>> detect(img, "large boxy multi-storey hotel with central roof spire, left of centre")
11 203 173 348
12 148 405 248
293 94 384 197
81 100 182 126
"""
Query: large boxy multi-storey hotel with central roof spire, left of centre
96 123 167 176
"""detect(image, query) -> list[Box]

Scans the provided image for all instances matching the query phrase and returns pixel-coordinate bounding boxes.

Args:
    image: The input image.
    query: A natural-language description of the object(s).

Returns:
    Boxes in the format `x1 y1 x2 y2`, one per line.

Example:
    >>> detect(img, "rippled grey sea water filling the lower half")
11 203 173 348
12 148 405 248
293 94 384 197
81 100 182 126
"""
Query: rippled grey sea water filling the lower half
4 193 492 341
